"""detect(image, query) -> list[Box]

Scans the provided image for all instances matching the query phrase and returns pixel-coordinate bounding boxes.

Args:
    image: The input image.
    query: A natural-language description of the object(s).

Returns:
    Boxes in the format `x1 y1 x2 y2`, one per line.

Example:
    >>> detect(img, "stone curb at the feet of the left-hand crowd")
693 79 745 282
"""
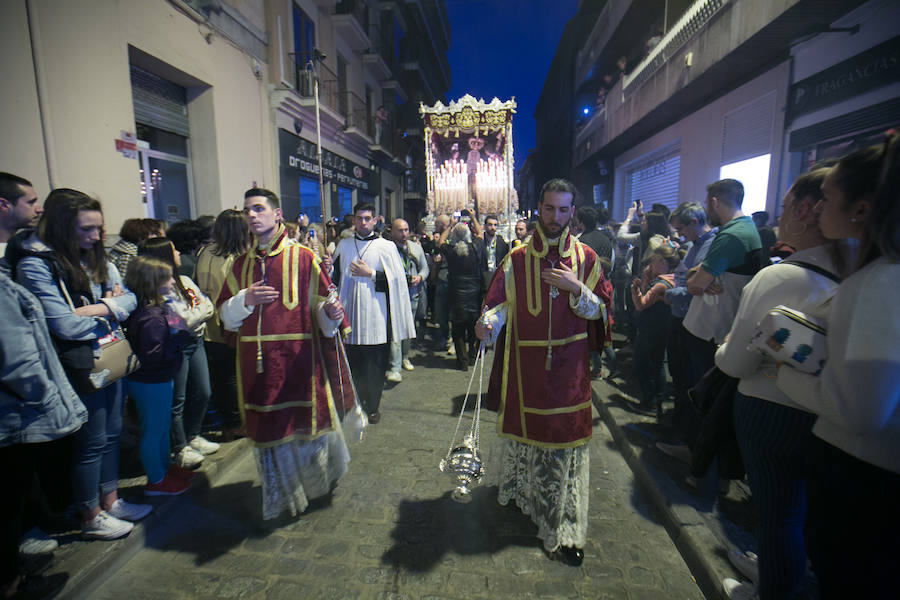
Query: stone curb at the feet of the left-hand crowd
50 438 251 600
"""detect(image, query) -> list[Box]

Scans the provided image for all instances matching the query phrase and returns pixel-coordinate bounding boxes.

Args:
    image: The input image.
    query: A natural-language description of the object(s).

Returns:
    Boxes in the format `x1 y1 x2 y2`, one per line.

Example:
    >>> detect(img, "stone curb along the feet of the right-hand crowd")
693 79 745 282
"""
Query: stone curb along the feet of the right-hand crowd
591 384 725 600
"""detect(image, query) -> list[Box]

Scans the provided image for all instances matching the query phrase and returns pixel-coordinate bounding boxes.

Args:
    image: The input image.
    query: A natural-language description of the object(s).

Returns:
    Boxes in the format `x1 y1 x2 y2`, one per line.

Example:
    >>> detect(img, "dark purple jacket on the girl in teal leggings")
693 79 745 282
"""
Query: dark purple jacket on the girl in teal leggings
125 306 187 383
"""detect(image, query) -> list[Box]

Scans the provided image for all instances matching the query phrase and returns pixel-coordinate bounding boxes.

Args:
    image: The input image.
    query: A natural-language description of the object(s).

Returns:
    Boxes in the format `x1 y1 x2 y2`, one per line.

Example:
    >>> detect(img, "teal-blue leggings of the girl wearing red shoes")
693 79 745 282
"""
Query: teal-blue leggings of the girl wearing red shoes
125 379 173 483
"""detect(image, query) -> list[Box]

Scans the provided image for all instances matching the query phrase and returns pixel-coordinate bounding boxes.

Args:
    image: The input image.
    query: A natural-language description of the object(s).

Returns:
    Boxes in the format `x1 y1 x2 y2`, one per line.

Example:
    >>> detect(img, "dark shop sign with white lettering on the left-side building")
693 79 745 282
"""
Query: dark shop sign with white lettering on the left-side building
278 129 374 191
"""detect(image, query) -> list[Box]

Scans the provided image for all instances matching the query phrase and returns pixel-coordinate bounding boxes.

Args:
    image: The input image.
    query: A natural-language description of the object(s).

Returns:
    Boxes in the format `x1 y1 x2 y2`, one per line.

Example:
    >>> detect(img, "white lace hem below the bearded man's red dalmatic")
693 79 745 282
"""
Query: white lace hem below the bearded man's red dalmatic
491 438 590 552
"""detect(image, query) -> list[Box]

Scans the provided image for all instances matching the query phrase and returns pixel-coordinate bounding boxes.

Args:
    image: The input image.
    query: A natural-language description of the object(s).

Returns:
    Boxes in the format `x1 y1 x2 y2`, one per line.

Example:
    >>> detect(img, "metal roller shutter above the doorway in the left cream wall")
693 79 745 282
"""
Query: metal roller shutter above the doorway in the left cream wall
131 65 190 137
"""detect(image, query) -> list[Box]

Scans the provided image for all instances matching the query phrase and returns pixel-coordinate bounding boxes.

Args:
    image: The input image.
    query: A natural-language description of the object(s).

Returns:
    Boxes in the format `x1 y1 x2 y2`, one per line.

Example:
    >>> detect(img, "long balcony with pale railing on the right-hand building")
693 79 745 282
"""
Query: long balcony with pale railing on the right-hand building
573 0 863 166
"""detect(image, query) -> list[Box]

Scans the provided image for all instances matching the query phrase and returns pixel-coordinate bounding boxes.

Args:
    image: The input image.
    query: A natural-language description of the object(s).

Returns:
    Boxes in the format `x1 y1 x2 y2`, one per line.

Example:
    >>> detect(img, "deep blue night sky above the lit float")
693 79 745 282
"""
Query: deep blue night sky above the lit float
444 0 578 168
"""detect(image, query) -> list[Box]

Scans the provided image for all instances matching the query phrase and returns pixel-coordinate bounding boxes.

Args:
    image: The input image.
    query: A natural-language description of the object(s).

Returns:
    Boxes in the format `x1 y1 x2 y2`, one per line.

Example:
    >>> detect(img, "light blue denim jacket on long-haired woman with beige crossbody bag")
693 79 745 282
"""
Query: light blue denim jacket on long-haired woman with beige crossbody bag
7 235 137 341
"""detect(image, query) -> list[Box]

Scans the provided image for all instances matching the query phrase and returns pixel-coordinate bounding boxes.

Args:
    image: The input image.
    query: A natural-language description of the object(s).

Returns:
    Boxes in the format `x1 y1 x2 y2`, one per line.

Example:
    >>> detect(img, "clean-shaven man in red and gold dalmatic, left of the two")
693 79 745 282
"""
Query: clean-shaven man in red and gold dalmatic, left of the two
217 188 354 519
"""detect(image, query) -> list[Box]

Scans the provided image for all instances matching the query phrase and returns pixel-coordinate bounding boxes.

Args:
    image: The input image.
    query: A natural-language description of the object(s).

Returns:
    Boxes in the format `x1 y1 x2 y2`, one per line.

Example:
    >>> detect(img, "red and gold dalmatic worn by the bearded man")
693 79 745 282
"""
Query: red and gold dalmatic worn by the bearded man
484 227 610 449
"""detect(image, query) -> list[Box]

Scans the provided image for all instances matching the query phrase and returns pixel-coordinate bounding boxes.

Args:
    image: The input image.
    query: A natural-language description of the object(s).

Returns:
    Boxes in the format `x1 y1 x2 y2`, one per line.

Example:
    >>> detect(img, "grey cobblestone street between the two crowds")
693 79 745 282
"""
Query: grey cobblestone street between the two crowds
91 352 702 600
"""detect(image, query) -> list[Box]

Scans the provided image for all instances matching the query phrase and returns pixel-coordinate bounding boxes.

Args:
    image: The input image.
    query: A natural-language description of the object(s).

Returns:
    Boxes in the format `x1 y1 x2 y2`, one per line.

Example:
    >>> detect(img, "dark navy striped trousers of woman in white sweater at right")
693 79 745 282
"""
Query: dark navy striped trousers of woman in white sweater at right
734 392 820 600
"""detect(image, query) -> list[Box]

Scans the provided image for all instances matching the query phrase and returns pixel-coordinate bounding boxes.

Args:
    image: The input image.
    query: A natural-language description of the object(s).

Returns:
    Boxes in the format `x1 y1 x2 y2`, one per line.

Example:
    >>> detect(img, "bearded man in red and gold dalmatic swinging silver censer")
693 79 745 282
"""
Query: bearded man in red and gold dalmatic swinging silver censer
475 179 610 566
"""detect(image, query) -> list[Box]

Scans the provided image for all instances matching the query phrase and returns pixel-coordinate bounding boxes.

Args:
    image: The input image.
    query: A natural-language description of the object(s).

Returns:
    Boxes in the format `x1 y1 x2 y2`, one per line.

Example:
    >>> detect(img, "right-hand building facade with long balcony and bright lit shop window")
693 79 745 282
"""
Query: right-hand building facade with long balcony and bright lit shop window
536 0 900 219
